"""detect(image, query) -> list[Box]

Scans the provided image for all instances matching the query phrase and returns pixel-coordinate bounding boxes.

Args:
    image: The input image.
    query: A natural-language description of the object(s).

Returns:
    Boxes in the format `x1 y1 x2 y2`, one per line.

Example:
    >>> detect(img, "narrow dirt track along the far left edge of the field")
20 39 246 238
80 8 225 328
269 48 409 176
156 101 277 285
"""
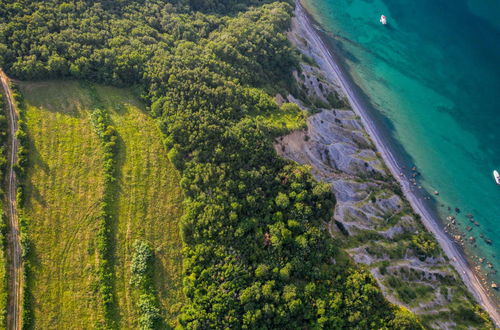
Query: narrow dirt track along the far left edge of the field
0 69 22 329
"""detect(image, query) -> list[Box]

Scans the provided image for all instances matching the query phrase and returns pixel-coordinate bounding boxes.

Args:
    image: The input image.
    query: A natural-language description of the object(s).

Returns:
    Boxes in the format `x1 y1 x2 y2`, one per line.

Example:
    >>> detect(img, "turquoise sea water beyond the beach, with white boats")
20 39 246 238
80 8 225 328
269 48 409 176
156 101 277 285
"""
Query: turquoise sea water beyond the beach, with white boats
304 0 500 283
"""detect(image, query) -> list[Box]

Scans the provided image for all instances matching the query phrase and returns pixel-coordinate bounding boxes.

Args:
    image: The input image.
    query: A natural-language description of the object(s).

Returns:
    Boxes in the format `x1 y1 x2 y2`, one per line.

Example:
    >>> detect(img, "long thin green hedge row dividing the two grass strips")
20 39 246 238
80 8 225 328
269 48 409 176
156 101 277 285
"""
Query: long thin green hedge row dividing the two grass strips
91 109 117 328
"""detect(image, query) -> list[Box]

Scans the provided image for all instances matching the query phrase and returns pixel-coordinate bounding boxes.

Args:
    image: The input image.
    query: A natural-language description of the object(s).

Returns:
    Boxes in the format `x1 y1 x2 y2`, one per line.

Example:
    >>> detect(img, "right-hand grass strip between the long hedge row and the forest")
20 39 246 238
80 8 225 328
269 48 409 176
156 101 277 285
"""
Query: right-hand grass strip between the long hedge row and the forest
92 87 183 329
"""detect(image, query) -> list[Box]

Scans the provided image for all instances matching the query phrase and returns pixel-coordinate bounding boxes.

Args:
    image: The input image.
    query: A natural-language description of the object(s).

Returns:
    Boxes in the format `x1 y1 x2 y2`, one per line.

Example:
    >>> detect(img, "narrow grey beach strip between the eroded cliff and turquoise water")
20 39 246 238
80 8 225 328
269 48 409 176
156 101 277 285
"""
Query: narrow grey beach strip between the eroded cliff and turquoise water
295 1 500 327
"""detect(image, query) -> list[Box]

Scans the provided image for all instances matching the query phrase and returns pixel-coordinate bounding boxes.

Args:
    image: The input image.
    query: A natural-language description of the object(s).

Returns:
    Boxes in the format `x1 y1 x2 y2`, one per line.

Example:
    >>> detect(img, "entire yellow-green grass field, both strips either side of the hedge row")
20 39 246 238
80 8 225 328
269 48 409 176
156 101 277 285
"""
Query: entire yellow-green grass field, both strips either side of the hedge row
21 81 182 329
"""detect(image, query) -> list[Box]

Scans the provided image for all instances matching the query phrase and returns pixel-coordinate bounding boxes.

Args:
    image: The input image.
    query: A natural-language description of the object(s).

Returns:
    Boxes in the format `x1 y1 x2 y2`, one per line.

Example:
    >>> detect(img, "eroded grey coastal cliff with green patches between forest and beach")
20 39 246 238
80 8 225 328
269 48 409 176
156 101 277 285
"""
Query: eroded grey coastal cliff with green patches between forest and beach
275 5 494 329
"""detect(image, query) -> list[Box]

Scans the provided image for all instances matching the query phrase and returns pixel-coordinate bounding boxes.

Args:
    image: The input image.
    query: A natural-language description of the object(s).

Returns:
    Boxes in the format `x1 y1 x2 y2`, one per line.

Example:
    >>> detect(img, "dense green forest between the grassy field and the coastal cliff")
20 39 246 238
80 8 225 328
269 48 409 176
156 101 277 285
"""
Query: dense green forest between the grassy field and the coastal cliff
0 0 426 329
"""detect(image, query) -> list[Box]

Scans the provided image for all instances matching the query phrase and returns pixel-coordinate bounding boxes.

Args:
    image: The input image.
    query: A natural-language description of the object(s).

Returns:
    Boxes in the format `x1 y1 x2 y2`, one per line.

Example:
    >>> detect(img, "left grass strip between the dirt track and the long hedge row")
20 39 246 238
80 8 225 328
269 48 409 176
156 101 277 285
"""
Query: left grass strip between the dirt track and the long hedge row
21 82 103 329
